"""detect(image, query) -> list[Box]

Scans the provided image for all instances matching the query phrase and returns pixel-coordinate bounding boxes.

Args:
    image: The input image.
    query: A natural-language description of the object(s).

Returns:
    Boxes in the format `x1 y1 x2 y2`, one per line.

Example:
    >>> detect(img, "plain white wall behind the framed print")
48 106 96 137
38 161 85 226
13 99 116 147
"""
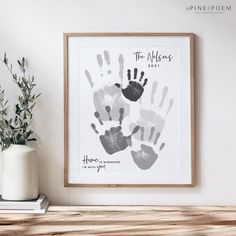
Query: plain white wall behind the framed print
0 0 236 205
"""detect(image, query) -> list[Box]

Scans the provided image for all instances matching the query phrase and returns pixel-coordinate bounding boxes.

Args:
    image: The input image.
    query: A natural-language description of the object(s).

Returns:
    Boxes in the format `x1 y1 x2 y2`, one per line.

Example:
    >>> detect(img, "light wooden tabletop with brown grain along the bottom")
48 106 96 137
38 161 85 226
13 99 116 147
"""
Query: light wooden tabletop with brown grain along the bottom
0 206 236 236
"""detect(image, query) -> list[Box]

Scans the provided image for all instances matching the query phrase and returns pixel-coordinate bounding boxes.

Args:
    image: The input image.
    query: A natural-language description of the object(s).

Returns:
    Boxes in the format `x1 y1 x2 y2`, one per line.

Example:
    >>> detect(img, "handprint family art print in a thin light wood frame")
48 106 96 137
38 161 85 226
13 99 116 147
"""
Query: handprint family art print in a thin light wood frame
64 33 195 187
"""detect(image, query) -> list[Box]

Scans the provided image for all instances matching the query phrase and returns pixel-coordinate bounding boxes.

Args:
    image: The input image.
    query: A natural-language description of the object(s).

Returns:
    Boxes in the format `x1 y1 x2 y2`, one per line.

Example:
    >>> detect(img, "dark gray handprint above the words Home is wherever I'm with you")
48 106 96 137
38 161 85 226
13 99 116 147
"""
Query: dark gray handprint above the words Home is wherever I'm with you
91 106 140 155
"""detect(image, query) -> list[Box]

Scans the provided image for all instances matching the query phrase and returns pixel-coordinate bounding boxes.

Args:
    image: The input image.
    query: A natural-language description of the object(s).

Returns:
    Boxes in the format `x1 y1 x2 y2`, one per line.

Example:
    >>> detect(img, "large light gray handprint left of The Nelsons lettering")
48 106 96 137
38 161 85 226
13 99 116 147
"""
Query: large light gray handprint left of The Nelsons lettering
85 50 130 121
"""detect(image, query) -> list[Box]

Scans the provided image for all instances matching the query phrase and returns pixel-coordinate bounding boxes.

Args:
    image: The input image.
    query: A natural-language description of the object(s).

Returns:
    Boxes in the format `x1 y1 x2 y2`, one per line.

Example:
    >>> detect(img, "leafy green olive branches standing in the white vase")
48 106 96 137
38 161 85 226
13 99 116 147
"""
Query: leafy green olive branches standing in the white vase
0 53 41 150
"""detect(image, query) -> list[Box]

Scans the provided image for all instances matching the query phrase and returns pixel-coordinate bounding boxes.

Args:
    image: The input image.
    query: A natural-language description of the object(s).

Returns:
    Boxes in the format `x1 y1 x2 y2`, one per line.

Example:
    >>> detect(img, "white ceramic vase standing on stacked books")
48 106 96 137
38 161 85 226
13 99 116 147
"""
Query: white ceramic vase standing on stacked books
2 145 38 201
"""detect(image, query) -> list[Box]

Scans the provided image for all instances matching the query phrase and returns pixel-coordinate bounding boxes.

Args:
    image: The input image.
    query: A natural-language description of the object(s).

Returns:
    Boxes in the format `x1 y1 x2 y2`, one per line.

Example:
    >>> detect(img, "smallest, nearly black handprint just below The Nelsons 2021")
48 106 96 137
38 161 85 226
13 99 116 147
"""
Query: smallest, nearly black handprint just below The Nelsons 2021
115 68 148 102
